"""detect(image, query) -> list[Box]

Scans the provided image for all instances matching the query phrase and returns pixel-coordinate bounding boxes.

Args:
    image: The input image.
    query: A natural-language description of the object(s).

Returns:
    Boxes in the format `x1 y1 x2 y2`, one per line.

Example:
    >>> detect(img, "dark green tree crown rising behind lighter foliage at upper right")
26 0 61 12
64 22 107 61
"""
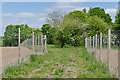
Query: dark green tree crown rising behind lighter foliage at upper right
88 7 112 23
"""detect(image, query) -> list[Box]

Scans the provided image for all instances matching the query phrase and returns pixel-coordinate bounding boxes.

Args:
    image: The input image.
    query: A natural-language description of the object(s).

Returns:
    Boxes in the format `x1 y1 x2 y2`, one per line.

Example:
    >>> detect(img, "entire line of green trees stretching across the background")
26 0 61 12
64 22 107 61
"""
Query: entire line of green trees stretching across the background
3 7 120 47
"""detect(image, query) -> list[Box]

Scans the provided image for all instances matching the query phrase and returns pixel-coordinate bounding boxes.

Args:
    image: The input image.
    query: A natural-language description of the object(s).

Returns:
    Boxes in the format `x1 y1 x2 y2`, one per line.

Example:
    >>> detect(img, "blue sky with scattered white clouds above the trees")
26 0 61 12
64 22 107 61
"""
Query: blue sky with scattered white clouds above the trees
2 0 118 35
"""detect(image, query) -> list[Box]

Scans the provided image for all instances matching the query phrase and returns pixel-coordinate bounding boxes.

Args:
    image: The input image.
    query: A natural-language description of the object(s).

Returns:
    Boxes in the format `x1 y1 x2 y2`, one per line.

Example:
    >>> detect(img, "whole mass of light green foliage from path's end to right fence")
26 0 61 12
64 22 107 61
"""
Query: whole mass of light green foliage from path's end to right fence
54 10 111 47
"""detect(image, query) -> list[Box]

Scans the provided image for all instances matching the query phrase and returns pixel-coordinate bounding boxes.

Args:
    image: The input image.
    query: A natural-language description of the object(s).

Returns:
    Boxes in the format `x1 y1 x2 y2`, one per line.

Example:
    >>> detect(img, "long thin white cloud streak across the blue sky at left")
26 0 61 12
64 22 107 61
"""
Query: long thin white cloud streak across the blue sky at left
2 12 46 18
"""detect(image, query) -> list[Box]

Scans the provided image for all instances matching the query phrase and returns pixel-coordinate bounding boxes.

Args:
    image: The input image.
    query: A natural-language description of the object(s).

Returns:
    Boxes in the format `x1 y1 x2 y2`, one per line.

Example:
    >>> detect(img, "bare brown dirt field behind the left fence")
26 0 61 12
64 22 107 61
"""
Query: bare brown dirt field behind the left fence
2 47 34 67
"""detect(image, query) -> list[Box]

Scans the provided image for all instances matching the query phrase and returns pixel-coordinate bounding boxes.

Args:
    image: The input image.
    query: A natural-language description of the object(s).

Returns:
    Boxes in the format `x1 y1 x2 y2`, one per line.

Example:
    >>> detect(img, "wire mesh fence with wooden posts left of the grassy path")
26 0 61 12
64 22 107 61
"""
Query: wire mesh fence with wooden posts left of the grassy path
0 28 47 72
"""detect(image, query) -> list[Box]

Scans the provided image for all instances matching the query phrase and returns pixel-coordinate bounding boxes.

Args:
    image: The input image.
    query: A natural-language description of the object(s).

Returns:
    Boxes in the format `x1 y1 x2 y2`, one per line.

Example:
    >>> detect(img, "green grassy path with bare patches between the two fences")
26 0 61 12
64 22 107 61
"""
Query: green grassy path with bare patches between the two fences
3 45 114 78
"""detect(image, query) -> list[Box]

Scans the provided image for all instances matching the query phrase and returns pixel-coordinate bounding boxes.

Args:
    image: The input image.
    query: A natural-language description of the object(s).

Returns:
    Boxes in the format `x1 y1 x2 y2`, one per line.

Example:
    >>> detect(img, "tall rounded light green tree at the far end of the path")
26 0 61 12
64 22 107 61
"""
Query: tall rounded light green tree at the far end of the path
54 10 87 47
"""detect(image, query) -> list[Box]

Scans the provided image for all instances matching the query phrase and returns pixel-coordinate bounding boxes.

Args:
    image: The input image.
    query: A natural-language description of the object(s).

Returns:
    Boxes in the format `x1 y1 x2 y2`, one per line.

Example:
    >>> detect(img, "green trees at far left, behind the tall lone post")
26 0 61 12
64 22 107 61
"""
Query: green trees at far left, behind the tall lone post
3 24 32 46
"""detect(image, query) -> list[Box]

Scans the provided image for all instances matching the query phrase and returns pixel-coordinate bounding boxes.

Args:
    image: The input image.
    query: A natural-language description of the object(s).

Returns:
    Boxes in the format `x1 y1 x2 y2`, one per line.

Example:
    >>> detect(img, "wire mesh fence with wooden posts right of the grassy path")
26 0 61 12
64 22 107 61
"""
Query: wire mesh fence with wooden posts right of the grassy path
85 30 120 77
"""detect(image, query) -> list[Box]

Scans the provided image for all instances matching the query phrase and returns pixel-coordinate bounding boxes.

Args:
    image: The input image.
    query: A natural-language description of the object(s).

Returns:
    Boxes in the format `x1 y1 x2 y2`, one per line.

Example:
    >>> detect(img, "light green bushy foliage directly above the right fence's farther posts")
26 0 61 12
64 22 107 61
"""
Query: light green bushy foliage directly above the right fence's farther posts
86 16 110 36
